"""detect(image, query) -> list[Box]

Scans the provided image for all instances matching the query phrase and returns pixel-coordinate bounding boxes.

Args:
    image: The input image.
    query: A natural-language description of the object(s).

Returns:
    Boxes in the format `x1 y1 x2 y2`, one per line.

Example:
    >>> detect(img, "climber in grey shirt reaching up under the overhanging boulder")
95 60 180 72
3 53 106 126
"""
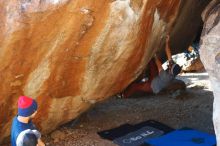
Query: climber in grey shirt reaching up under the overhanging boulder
118 35 185 98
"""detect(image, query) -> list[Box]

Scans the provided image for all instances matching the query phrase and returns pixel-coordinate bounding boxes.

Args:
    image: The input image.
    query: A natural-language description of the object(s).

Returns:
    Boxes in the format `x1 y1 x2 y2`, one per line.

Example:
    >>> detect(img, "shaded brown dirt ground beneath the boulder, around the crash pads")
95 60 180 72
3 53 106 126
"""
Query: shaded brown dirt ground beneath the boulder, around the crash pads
43 73 214 146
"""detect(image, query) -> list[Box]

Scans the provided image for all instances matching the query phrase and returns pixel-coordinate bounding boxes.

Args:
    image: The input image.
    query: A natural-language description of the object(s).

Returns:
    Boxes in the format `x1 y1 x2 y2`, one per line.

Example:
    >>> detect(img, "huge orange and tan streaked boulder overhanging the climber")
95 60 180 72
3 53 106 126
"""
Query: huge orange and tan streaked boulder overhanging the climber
0 0 210 142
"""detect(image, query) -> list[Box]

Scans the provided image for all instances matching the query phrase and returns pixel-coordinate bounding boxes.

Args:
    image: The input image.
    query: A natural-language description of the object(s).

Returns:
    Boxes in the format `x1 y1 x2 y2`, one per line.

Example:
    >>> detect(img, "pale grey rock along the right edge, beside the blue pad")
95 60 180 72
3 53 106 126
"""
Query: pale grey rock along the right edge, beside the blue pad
201 0 220 146
